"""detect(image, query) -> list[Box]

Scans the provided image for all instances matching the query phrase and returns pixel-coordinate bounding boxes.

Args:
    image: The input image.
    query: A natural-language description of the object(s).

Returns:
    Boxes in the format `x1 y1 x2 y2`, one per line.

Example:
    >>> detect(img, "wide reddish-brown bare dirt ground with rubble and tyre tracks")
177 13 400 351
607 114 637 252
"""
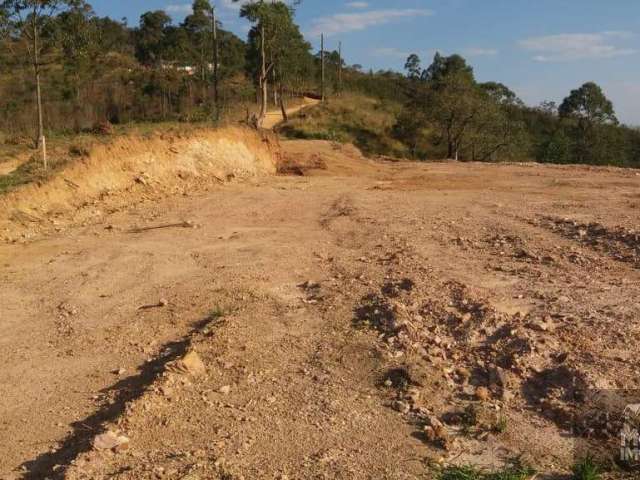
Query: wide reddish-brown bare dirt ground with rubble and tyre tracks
0 137 640 480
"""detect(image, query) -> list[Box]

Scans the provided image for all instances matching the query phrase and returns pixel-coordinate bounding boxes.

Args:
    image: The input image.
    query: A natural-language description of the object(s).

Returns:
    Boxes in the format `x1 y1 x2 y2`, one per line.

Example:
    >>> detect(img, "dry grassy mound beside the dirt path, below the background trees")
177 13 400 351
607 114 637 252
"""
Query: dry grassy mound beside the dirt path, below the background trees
278 94 408 157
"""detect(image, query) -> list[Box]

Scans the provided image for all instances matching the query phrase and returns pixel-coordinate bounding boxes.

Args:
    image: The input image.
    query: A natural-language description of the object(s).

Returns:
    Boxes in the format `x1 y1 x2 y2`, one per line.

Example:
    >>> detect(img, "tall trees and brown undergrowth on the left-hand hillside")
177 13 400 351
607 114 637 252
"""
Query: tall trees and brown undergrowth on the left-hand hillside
0 0 338 138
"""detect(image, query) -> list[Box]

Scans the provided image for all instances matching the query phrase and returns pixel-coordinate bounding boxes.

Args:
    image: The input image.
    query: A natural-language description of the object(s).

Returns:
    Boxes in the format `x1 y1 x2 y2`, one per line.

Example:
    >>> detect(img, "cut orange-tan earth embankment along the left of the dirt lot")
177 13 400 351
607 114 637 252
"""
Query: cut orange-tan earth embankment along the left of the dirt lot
0 127 279 238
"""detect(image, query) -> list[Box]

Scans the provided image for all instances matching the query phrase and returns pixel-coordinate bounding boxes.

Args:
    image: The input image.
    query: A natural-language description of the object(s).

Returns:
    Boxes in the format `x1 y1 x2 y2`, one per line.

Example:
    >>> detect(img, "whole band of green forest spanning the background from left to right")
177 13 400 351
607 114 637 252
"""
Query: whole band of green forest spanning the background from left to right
0 0 640 166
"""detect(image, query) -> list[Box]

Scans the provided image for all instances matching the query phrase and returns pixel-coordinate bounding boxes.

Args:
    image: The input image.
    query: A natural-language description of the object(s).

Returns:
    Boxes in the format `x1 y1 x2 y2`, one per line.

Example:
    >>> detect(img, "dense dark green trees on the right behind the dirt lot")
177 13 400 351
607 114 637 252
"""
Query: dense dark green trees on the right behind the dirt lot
376 54 640 167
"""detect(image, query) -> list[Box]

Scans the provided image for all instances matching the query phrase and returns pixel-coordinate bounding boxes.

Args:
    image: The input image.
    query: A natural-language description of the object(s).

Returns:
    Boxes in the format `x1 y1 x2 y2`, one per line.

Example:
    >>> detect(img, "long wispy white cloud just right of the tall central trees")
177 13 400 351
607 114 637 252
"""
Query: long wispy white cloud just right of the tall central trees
309 8 433 36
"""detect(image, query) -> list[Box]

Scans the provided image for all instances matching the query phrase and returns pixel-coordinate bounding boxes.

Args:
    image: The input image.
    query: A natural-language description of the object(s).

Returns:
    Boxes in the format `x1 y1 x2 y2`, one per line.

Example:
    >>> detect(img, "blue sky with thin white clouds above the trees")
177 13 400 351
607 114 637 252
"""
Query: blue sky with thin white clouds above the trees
90 0 640 125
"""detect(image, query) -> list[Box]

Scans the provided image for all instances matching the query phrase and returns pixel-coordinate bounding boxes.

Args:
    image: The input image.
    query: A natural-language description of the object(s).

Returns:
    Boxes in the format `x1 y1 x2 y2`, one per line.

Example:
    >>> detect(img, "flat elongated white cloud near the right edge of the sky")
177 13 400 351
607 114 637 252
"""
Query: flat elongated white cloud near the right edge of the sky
520 31 637 62
